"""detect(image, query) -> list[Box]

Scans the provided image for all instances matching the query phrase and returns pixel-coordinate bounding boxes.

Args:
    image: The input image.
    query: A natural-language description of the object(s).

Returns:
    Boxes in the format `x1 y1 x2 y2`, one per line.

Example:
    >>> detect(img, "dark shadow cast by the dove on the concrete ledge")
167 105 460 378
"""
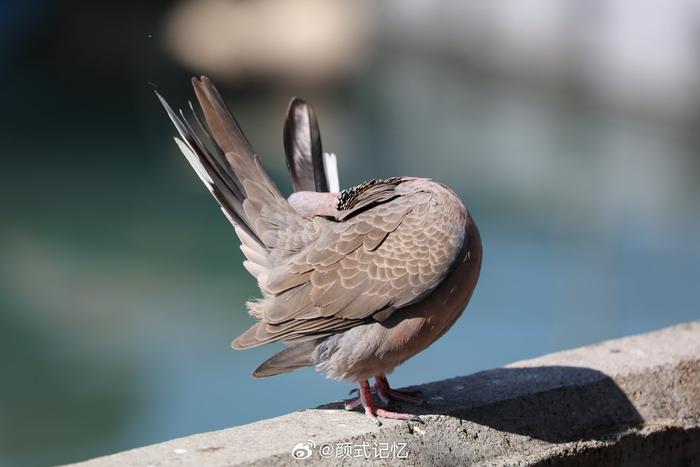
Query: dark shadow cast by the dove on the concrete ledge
322 366 643 443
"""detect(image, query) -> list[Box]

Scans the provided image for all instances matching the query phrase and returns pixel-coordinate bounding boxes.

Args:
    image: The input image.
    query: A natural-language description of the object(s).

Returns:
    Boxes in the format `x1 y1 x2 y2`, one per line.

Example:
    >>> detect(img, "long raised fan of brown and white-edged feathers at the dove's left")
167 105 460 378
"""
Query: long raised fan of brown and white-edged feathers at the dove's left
156 76 293 264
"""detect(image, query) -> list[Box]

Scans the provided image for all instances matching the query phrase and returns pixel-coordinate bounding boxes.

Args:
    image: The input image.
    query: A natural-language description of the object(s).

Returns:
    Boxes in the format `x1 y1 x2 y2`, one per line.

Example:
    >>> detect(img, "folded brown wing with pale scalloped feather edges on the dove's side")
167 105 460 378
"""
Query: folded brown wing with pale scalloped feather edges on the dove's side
233 179 464 348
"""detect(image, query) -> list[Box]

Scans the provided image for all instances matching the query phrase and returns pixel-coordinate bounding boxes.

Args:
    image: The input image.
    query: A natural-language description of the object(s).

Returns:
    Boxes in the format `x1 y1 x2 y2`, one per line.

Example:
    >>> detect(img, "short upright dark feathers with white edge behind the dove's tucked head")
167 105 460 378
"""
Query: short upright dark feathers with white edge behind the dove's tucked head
284 97 339 192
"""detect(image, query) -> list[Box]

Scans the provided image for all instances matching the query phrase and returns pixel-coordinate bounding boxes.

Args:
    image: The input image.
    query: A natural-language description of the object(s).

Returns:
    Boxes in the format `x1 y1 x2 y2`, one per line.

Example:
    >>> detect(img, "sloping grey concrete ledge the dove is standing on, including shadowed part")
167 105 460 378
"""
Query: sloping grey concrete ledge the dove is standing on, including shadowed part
76 321 700 467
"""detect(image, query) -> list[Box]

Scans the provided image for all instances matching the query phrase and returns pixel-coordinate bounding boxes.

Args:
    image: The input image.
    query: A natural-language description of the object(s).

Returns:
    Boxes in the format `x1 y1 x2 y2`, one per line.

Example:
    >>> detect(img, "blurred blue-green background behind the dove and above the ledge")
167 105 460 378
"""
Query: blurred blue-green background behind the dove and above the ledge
0 0 700 466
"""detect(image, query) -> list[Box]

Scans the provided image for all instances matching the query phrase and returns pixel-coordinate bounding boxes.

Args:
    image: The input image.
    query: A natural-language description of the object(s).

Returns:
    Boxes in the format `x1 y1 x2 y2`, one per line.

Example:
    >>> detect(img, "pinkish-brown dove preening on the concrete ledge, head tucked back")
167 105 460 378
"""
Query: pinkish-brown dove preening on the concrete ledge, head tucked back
156 76 482 425
